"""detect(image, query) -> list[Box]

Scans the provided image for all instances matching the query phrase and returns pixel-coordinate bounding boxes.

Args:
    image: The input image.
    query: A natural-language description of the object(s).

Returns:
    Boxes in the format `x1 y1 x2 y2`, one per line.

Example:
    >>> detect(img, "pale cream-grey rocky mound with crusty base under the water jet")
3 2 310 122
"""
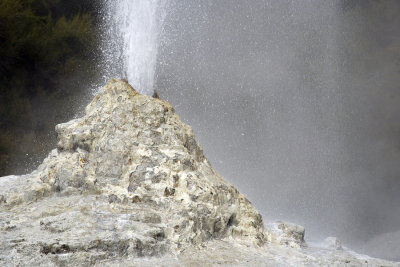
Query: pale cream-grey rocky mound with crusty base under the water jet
0 80 396 266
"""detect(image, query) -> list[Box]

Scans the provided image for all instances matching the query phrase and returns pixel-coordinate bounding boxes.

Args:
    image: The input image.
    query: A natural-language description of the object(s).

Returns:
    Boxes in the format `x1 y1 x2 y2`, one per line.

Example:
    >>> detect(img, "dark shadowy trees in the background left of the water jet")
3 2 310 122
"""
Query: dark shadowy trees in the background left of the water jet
0 0 101 176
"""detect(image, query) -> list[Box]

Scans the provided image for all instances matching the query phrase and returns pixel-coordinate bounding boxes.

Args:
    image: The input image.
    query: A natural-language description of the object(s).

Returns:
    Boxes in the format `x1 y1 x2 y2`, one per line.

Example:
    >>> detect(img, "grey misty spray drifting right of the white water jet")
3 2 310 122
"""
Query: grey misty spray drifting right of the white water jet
150 0 400 260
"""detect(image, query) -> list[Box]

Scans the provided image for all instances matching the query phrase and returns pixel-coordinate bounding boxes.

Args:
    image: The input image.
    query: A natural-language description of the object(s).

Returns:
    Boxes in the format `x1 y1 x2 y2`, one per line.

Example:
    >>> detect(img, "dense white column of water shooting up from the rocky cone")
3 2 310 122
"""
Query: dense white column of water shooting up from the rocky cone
107 0 166 94
